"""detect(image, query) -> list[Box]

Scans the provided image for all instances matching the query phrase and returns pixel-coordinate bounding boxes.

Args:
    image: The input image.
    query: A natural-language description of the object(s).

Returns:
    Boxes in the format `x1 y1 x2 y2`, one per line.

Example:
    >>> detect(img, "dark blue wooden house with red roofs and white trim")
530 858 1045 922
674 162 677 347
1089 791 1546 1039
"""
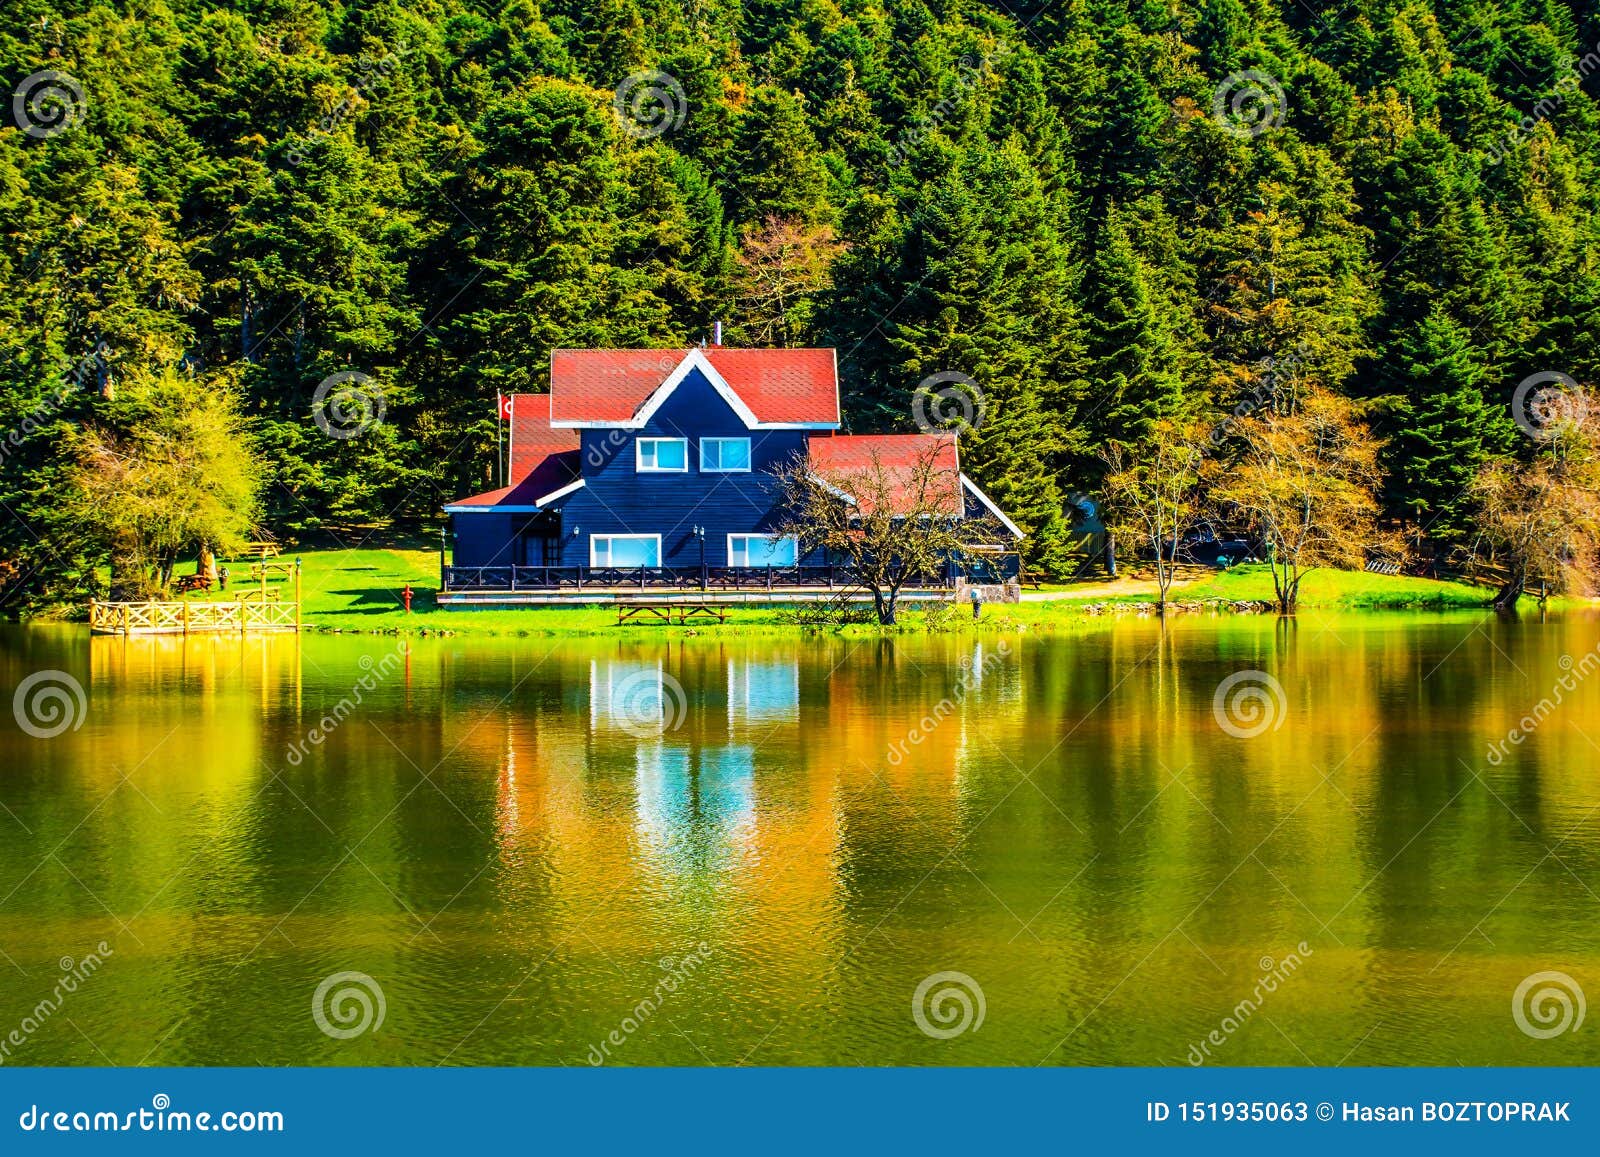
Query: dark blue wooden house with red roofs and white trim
445 346 1021 591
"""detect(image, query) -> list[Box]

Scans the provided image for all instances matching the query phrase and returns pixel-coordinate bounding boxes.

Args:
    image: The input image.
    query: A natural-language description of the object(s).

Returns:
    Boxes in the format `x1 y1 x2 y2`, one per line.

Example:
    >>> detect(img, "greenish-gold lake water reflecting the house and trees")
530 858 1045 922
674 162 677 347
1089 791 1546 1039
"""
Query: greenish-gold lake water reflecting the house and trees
0 615 1600 1066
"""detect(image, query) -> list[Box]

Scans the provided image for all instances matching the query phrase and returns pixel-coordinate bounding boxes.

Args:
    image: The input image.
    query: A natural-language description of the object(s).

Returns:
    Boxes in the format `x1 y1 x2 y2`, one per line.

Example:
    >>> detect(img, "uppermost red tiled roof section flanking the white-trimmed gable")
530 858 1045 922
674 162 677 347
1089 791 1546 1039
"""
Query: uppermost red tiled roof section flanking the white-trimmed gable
550 353 838 426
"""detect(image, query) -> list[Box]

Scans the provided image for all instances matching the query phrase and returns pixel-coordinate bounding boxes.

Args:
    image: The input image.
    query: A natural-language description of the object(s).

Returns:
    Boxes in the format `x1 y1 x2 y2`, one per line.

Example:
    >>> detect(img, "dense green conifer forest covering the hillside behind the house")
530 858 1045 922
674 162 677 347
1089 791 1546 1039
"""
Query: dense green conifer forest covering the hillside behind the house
0 0 1600 613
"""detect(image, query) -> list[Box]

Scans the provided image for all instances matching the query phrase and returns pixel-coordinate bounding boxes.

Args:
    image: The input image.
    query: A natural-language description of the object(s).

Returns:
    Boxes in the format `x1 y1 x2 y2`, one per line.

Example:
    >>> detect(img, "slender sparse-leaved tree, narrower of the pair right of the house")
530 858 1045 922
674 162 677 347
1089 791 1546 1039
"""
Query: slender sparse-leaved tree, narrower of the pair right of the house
1101 419 1206 615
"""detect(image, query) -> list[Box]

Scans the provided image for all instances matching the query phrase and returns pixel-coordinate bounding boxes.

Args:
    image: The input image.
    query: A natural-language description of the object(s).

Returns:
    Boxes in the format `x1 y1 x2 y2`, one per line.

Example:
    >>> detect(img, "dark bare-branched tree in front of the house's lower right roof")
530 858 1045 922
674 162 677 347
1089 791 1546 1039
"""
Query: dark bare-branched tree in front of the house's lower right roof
776 443 1000 626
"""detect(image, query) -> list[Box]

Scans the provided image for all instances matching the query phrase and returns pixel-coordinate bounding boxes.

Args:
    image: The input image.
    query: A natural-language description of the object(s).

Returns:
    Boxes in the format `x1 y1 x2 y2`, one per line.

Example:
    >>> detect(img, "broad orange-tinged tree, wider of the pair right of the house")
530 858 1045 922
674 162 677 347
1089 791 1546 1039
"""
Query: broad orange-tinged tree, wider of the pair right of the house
1206 386 1387 613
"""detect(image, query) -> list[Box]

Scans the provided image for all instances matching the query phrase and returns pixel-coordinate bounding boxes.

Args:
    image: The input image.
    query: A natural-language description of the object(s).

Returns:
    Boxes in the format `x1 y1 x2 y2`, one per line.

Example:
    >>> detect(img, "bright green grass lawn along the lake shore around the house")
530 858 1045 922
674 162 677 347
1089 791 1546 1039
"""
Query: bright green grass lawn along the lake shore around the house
150 549 1523 635
